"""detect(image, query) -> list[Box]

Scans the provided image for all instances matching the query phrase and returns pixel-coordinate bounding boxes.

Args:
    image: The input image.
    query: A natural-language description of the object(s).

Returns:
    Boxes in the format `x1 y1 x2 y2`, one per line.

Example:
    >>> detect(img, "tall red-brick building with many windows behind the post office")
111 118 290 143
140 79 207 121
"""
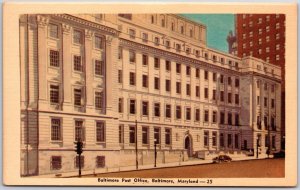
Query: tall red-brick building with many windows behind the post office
227 14 285 148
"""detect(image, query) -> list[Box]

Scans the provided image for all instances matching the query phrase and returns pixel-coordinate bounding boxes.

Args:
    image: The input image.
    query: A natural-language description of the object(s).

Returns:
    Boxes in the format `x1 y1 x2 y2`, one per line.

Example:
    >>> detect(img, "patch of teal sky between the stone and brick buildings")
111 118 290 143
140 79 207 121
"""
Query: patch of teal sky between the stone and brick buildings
182 14 234 52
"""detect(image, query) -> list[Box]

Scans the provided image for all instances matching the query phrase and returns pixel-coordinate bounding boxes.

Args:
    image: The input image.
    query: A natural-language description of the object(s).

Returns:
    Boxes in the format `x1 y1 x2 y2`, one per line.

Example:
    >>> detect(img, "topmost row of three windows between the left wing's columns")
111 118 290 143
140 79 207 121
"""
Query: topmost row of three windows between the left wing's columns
48 23 104 50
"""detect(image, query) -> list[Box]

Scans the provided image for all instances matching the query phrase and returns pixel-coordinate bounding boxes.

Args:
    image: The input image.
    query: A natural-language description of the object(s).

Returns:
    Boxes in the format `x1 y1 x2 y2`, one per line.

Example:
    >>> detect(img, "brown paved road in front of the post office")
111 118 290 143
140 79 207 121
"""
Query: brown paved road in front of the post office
85 159 285 178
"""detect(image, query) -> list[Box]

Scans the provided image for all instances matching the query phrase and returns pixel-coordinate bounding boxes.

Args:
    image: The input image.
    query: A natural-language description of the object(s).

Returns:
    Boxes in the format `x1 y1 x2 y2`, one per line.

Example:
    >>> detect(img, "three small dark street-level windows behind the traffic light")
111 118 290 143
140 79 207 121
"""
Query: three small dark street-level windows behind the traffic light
50 156 105 170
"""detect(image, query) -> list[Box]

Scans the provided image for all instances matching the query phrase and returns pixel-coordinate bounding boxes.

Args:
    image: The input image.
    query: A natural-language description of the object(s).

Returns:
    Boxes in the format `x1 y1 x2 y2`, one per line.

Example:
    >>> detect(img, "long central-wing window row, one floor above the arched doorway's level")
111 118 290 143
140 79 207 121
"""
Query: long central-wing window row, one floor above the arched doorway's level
119 98 239 125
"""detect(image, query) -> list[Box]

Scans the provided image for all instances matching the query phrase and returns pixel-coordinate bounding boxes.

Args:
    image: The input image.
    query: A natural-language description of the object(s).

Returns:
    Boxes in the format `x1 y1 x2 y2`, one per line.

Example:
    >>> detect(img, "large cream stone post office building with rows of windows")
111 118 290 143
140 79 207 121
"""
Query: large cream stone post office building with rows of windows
20 14 281 175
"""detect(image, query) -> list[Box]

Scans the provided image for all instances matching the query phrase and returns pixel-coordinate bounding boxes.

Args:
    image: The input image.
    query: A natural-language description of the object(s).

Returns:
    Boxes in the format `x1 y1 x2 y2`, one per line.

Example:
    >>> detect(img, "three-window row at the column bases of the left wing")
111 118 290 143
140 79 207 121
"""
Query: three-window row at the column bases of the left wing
50 84 104 110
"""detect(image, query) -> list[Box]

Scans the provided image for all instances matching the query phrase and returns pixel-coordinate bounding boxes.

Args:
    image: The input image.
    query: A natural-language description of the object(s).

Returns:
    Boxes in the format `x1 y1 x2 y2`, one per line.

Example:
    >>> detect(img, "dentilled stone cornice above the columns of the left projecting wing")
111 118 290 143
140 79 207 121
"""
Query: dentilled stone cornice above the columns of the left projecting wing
51 14 120 36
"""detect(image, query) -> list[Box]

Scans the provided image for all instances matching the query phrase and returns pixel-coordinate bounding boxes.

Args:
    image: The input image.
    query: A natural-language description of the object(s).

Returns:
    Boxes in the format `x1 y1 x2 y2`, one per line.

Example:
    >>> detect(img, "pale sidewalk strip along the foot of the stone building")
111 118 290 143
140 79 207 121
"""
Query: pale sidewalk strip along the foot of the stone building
32 156 271 178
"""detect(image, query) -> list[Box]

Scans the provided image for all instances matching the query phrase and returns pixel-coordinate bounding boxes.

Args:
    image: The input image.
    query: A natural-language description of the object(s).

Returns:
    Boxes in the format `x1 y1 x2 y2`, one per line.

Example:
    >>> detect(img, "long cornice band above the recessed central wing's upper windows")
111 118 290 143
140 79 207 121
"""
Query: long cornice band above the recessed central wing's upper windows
120 38 241 75
